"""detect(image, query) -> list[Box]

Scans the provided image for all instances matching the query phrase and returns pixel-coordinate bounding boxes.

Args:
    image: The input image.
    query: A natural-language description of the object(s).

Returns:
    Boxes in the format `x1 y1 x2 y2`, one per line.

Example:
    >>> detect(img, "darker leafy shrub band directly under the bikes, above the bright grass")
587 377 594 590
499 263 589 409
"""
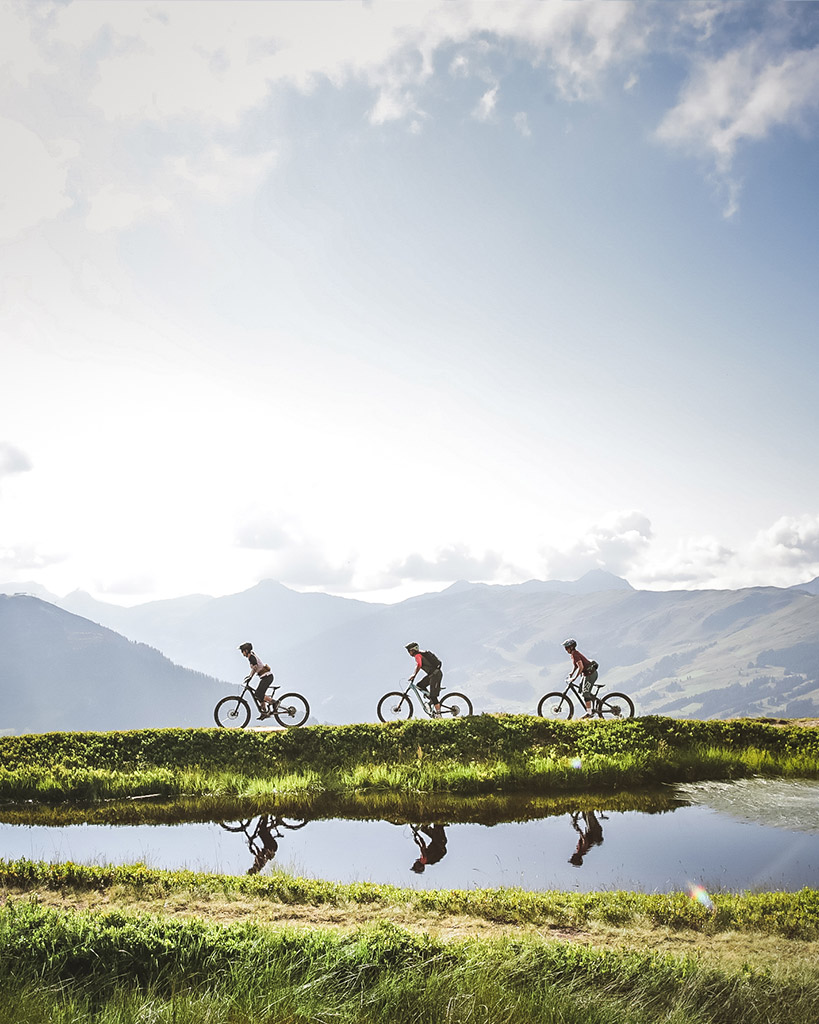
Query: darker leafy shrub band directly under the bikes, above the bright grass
0 715 819 774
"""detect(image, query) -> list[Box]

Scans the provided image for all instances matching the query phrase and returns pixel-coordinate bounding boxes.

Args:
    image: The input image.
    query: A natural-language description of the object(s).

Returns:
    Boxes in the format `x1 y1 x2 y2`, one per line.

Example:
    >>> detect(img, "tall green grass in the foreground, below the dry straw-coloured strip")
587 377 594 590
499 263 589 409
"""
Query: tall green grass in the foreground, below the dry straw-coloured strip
0 903 819 1024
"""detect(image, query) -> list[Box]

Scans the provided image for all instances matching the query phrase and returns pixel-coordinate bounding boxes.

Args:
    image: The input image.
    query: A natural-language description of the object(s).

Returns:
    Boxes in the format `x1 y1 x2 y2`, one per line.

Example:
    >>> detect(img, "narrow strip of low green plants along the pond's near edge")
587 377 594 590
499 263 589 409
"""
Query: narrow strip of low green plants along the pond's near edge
6 859 819 940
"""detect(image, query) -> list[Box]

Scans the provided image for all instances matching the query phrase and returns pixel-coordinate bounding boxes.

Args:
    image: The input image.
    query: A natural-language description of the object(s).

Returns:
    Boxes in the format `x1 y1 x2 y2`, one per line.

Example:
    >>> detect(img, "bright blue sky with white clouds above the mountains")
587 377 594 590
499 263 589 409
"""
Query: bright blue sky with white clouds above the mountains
0 0 819 604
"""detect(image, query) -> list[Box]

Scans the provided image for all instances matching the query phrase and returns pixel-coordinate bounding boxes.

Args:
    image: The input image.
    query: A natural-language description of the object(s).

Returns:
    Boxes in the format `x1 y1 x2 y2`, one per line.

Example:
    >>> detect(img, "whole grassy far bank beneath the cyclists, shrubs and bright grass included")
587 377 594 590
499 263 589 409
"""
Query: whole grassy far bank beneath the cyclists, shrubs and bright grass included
0 715 819 809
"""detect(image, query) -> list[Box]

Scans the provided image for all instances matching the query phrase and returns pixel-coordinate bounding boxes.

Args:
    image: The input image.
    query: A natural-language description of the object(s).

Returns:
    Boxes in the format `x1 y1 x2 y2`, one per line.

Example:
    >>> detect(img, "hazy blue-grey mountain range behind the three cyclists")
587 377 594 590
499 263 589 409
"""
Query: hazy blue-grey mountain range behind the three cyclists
0 570 819 731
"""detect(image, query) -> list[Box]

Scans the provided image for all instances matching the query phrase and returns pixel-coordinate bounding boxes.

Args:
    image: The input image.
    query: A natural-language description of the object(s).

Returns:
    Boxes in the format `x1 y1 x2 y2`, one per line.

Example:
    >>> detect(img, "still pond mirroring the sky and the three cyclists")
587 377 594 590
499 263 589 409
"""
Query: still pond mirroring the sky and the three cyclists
0 779 819 892
